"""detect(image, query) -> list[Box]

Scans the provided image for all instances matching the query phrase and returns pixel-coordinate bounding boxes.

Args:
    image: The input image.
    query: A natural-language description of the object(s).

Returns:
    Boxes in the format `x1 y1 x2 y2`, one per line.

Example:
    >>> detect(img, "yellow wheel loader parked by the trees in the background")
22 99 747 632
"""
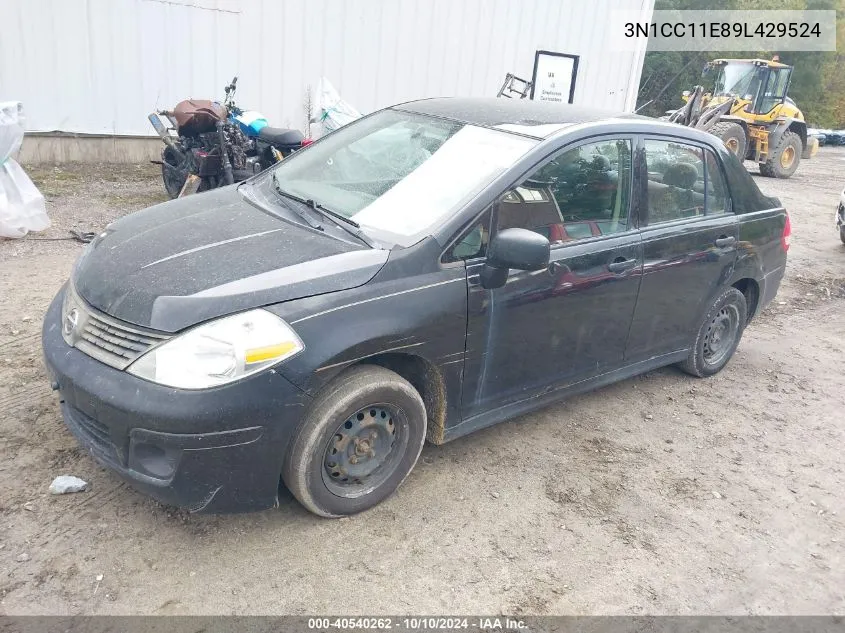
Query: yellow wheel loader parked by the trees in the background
668 58 819 178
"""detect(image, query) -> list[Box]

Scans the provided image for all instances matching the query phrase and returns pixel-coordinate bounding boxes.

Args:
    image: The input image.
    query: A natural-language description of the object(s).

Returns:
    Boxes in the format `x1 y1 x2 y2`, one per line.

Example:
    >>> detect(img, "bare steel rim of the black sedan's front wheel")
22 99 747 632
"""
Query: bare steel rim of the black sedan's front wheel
321 403 408 499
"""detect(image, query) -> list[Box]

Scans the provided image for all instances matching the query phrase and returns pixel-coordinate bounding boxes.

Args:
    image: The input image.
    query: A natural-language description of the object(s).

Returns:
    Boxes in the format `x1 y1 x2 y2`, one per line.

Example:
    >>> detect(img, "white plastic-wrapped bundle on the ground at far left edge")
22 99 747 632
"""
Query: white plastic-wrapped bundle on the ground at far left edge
0 101 50 237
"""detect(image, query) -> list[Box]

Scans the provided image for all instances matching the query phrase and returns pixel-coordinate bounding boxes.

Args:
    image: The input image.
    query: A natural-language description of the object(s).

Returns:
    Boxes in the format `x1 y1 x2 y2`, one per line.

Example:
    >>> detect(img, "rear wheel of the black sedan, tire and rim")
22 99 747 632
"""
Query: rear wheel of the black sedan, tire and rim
678 288 748 378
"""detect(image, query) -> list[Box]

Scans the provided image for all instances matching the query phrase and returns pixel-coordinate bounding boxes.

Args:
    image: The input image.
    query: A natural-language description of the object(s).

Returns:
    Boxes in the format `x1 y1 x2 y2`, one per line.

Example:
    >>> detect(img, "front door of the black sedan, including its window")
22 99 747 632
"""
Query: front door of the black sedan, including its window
462 138 642 420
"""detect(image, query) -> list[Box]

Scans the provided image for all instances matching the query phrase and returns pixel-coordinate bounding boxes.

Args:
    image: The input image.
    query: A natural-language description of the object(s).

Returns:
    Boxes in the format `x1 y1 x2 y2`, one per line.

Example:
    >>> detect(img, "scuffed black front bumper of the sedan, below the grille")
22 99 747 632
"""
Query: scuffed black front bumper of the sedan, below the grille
42 290 309 512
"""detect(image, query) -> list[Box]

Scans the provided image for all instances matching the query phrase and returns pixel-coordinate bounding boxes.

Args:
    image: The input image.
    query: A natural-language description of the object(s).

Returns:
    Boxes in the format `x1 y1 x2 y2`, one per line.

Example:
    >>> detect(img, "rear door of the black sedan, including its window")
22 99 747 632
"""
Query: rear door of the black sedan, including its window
626 137 739 362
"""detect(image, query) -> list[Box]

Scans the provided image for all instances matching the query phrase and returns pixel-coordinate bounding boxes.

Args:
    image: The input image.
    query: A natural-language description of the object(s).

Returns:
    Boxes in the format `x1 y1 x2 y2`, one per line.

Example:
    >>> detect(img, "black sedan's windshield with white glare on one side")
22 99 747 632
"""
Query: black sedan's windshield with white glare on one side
274 110 537 246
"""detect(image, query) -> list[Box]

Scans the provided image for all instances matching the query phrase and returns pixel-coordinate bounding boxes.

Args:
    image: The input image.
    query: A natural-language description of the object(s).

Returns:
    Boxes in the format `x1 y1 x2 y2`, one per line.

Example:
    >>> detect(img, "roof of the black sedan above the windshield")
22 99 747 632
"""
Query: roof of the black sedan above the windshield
393 97 649 138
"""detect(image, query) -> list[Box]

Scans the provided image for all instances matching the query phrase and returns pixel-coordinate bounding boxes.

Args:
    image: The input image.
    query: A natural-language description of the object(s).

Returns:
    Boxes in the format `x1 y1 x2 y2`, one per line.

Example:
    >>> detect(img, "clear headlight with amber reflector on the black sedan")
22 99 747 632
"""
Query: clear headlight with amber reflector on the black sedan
126 309 305 389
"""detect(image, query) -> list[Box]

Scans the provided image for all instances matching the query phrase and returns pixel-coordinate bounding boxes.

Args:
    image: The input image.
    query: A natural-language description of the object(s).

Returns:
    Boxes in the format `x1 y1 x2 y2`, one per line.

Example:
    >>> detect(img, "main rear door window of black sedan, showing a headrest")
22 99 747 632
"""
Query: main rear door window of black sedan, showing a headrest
645 140 705 224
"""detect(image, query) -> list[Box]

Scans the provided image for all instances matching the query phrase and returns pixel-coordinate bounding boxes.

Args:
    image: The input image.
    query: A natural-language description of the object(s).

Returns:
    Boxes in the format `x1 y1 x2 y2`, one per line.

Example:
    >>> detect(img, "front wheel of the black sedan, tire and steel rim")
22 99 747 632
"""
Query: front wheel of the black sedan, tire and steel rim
282 365 426 518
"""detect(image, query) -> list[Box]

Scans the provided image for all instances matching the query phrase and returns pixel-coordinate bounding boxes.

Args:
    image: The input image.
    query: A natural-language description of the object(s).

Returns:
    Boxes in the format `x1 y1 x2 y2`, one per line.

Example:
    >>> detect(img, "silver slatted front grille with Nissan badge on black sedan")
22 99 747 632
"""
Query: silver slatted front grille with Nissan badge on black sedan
62 288 169 369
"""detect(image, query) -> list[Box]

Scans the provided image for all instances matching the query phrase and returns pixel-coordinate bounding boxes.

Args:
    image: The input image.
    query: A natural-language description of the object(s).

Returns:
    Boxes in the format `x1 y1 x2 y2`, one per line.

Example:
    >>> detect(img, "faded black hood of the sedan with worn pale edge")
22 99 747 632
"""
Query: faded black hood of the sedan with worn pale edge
73 187 389 332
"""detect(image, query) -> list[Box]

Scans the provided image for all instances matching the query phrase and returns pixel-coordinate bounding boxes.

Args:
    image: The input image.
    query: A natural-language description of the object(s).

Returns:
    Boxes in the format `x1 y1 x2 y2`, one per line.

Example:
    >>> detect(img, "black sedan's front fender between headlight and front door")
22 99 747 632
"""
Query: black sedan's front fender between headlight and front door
268 267 467 425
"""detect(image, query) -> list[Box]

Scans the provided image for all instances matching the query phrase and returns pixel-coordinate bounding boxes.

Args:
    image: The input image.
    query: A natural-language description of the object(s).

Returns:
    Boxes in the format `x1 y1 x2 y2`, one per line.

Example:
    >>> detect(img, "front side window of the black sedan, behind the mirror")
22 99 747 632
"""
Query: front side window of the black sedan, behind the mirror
496 139 632 244
